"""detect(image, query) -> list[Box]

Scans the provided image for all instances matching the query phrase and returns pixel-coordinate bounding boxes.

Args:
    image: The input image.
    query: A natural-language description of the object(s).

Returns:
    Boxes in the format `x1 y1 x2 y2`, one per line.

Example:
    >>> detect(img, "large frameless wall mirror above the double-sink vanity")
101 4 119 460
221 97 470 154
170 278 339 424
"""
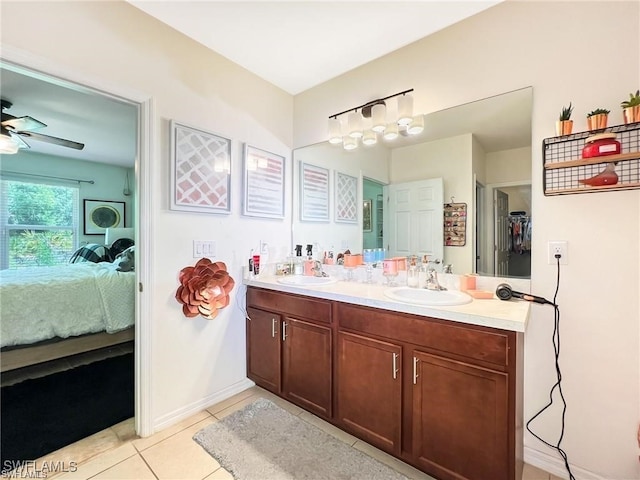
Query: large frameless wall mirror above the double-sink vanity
292 87 533 278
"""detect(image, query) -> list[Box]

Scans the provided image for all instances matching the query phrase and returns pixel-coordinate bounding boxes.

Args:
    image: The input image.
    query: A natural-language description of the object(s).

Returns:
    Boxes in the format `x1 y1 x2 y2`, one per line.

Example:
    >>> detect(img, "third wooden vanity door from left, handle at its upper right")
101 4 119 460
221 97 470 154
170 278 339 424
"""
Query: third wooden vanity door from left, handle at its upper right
336 332 402 455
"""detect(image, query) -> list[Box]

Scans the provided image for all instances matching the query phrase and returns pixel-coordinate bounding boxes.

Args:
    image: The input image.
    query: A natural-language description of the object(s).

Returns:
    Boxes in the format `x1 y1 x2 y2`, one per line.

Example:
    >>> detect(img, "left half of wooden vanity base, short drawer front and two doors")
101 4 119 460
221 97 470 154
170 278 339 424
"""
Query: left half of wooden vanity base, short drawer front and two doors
246 287 333 418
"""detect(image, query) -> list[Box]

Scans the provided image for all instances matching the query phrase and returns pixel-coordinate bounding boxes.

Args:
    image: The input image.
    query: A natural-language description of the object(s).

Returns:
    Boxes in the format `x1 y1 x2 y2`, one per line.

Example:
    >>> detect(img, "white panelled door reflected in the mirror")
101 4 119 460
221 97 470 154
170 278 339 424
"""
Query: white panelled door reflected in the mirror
383 178 444 260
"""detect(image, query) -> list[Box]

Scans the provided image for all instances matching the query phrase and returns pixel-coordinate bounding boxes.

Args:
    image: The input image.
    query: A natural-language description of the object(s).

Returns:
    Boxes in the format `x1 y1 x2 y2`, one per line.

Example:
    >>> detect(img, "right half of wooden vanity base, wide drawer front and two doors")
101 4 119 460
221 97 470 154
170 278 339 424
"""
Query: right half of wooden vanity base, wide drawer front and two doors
334 303 522 480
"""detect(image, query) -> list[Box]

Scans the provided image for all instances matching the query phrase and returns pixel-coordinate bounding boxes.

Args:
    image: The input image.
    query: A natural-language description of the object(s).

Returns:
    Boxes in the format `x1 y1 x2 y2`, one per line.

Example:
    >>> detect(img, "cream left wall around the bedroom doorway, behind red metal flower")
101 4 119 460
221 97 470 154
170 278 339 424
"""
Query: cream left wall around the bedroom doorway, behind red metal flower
1 2 293 428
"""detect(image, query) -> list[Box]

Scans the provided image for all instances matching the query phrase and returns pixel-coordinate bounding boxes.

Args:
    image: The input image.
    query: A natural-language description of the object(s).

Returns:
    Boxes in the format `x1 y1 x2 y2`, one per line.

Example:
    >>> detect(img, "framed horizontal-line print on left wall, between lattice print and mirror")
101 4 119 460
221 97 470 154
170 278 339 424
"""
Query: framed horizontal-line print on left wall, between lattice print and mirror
242 144 285 218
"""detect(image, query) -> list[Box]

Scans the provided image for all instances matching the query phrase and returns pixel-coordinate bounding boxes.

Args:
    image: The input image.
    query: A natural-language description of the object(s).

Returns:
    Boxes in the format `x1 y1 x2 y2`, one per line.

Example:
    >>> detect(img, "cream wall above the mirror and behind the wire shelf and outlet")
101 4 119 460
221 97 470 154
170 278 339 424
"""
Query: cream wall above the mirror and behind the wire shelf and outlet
294 1 640 479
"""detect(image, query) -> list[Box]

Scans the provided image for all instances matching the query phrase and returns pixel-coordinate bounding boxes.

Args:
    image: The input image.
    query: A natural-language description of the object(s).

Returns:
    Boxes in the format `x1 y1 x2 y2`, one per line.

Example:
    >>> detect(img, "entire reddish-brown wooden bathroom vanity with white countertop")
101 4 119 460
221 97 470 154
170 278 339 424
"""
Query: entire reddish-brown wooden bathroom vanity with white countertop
246 277 530 480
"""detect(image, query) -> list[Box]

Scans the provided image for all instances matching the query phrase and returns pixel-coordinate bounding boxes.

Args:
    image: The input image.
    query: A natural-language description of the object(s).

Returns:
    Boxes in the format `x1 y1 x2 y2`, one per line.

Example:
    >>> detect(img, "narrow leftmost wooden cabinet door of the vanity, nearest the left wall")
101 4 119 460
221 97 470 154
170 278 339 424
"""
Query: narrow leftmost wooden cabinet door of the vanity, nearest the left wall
247 308 281 393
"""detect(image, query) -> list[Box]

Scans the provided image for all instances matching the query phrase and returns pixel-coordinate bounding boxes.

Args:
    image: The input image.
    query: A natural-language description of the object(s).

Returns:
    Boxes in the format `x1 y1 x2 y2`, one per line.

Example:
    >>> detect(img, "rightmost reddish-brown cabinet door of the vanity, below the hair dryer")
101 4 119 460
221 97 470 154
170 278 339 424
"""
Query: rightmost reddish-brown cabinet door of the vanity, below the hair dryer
412 351 509 480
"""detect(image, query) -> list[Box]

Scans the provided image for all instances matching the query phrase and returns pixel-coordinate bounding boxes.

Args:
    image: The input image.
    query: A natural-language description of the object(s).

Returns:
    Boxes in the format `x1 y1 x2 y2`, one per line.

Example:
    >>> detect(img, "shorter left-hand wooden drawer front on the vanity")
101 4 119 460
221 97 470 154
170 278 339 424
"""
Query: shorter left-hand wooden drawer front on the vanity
247 287 331 323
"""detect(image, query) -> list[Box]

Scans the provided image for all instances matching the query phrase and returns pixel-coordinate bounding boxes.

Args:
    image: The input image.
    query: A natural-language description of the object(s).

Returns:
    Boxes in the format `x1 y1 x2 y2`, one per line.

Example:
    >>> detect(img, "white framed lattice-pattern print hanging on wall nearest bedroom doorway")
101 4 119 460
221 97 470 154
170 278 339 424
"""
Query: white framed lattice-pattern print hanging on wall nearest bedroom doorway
170 121 231 213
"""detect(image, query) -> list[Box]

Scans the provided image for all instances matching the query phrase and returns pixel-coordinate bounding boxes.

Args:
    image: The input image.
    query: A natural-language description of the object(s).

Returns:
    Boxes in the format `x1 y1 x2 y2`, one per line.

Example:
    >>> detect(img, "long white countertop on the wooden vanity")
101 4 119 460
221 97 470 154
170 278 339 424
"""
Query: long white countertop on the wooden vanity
244 273 531 332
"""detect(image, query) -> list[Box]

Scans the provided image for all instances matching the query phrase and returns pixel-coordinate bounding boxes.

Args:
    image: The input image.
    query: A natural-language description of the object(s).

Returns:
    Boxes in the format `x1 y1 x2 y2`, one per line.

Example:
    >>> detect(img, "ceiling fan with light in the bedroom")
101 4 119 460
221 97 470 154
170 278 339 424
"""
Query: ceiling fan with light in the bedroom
0 99 84 153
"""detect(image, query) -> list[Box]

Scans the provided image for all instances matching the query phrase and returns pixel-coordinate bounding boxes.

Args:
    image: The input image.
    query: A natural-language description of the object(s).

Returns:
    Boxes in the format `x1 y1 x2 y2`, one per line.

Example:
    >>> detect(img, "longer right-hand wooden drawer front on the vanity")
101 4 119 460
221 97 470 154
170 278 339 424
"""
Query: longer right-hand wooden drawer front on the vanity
336 303 509 366
